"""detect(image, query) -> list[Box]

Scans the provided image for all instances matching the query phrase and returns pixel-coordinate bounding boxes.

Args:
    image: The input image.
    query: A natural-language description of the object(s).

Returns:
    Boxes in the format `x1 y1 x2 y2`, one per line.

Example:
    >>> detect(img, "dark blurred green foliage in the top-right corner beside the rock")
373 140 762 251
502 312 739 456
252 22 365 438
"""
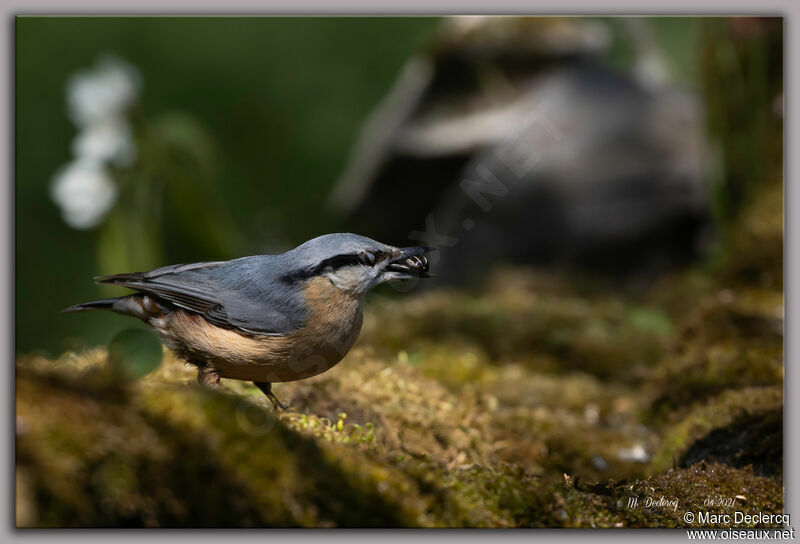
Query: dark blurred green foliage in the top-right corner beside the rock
699 17 784 227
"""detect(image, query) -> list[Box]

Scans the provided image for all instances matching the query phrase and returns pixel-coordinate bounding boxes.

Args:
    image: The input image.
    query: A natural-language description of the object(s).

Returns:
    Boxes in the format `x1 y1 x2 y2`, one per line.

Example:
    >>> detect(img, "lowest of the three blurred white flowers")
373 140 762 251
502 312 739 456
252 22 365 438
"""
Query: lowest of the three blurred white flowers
50 159 117 229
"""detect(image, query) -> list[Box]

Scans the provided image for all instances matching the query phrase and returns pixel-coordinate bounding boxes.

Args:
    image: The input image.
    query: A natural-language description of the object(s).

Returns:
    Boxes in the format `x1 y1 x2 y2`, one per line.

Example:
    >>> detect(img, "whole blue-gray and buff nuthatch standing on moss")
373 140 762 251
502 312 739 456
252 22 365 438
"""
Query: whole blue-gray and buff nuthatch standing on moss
64 233 434 411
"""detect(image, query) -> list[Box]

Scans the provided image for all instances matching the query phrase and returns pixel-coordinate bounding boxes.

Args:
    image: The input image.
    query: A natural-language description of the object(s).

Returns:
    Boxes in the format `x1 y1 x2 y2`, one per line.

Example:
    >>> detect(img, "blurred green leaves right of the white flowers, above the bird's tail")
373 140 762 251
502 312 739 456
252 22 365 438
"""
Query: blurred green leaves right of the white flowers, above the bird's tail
97 113 241 293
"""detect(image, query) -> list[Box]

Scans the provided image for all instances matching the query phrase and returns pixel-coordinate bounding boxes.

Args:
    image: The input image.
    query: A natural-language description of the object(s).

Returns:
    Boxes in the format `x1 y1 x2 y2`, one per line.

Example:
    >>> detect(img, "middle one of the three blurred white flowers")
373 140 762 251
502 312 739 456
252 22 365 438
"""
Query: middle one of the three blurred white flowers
72 116 136 167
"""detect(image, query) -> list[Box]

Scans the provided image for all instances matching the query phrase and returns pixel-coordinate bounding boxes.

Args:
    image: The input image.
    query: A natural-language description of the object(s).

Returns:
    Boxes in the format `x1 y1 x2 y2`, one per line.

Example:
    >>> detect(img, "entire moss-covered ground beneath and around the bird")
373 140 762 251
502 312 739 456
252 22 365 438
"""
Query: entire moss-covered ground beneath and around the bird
16 183 783 527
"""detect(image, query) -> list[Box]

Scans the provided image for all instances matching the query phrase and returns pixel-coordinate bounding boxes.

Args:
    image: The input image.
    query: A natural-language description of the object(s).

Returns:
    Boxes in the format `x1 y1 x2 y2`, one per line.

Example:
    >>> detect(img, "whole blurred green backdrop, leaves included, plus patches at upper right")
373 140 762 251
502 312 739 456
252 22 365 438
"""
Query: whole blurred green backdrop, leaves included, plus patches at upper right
15 17 772 354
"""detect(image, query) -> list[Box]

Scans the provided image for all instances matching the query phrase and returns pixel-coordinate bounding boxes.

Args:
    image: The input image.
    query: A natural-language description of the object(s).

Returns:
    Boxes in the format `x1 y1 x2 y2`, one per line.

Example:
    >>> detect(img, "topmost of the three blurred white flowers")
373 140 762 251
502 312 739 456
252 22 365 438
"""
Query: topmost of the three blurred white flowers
67 56 141 126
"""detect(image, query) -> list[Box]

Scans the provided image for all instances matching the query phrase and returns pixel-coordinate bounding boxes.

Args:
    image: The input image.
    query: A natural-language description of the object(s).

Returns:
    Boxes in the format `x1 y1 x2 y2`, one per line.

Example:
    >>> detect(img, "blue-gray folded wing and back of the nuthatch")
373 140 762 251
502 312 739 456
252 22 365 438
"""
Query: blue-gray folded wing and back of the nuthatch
95 255 306 335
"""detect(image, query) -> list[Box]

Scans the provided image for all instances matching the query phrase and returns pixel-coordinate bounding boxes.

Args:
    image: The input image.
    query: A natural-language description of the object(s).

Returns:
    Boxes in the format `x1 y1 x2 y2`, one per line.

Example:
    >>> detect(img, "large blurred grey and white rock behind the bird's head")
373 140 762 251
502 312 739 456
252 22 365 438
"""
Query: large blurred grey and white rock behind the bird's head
330 18 709 284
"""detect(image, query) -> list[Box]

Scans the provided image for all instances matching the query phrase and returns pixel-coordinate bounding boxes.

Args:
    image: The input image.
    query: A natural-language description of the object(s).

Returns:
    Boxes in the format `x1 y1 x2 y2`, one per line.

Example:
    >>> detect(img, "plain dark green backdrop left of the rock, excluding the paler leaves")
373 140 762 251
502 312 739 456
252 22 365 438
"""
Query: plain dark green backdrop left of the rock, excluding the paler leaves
16 17 444 353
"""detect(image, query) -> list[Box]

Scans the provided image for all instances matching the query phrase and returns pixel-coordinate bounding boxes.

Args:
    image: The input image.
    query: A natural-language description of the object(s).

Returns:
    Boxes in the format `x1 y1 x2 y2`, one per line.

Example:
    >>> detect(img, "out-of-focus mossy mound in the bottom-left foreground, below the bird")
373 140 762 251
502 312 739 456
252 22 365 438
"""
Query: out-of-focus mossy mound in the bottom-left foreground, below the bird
17 360 425 527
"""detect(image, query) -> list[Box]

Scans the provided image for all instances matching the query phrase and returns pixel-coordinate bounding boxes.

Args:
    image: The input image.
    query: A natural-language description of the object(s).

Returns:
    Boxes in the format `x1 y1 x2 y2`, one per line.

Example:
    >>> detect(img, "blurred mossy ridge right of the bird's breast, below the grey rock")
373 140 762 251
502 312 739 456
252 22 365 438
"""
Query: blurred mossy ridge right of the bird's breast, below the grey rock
363 282 671 378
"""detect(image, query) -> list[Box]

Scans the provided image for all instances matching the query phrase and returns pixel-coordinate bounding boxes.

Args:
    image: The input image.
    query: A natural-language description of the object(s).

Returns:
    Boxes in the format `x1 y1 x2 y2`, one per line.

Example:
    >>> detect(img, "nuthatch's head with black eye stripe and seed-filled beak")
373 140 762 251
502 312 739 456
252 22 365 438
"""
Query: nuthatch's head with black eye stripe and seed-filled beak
286 233 432 295
